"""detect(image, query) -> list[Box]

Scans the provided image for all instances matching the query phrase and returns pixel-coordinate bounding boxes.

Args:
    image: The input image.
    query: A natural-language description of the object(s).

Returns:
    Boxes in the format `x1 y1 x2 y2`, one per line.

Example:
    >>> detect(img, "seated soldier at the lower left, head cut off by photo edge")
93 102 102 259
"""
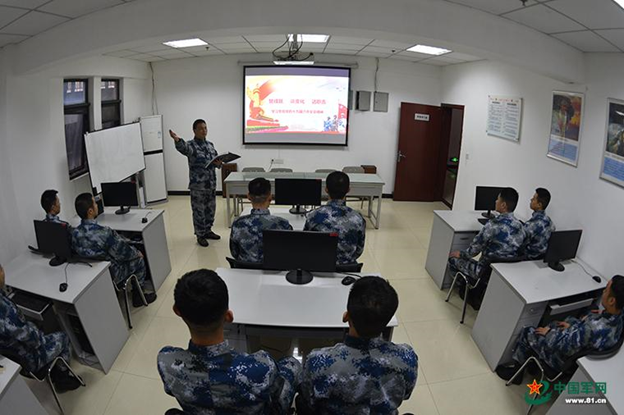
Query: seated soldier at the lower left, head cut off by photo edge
0 265 80 393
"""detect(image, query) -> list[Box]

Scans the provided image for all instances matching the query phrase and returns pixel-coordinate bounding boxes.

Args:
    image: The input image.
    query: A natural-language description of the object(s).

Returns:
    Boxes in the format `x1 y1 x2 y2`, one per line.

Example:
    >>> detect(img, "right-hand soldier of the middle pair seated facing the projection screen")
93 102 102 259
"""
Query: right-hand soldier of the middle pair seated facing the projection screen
303 171 366 264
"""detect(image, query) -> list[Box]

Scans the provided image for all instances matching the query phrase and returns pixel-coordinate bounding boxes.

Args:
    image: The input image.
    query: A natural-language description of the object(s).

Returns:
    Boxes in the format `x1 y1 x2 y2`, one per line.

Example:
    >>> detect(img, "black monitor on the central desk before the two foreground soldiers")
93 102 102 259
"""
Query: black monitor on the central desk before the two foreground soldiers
263 230 338 284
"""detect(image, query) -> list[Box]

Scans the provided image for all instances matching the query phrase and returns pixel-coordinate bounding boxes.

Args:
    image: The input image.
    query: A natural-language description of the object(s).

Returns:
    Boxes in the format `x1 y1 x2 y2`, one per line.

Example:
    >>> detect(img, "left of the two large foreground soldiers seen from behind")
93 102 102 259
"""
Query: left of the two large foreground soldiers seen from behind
158 269 301 414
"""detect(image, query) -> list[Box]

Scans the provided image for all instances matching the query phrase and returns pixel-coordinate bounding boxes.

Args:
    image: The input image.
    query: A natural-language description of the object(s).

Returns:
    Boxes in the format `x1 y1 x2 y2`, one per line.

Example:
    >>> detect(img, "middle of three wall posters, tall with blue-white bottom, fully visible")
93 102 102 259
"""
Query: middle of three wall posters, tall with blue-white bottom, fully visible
548 91 584 167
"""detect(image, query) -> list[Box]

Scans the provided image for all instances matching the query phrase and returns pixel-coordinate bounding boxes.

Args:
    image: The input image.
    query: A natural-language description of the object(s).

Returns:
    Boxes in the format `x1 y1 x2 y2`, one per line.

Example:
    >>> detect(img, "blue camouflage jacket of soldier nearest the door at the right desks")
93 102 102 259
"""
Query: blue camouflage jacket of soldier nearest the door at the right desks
460 212 525 260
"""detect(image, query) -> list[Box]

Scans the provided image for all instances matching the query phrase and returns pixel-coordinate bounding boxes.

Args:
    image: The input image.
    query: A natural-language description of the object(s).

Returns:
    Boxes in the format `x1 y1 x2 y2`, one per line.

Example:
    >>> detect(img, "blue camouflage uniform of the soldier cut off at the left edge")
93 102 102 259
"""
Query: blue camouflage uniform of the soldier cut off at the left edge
0 290 69 373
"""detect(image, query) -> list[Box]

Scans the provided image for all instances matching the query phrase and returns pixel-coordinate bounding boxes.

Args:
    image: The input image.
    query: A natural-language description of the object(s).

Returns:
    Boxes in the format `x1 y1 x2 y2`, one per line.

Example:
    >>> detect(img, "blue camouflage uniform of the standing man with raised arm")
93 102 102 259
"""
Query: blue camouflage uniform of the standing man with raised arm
175 139 218 238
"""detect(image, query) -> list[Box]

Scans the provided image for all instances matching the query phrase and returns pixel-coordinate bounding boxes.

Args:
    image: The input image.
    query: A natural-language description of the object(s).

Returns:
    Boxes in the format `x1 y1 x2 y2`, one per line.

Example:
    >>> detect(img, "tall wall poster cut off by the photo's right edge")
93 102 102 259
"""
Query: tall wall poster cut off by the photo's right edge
600 98 624 187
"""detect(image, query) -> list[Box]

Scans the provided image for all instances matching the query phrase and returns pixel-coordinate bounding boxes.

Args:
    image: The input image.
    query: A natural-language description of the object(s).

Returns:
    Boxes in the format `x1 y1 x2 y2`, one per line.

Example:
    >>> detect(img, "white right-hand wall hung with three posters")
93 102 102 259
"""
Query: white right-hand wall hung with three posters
442 55 624 277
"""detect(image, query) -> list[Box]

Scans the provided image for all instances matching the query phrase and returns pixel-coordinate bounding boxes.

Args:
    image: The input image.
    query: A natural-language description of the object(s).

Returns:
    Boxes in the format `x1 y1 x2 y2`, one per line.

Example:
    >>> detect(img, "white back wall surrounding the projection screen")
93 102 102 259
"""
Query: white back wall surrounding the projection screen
154 55 440 193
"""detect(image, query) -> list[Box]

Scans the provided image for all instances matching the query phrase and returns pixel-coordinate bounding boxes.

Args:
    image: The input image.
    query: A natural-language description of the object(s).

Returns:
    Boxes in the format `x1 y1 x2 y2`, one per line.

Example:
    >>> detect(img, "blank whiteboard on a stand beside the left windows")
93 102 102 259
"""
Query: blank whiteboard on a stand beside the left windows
85 123 145 193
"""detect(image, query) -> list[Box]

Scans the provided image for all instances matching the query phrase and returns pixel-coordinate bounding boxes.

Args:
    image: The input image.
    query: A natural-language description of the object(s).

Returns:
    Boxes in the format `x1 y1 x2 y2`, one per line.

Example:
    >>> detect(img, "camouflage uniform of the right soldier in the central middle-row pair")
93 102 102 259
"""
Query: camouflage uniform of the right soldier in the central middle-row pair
303 200 366 264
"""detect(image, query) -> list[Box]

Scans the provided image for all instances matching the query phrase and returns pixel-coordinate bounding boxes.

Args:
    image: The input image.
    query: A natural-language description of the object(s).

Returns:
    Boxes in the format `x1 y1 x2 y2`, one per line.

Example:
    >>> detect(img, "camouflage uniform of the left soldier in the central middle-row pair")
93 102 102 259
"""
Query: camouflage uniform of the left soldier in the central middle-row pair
230 209 292 263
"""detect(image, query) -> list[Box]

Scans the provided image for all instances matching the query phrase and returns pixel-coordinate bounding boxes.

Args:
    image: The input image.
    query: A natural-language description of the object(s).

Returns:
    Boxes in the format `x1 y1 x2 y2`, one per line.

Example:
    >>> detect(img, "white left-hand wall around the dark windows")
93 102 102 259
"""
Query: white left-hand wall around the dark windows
0 51 151 260
